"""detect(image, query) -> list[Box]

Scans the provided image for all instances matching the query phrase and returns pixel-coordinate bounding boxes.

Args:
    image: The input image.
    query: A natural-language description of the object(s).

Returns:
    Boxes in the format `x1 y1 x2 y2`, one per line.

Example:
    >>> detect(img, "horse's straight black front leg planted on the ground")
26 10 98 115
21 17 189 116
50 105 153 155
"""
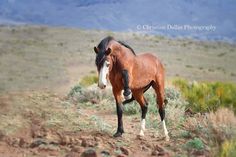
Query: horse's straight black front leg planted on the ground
113 89 124 137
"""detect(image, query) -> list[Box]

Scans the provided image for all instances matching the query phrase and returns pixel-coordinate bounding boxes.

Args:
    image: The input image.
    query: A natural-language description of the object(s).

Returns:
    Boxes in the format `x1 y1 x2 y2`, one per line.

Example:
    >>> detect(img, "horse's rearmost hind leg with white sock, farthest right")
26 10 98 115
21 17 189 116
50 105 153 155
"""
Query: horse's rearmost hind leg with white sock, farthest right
153 78 170 141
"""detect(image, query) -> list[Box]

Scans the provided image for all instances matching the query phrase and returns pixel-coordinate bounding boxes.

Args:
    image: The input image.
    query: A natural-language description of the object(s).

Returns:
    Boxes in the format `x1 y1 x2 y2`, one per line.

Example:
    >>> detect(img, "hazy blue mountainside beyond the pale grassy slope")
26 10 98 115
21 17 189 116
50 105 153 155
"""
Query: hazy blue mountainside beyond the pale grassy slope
0 0 236 41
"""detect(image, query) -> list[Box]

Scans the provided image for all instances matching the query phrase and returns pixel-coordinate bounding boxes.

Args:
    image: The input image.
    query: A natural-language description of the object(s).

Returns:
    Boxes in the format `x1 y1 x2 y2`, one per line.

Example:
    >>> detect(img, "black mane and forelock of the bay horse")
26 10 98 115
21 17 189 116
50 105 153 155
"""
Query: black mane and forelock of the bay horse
95 36 136 69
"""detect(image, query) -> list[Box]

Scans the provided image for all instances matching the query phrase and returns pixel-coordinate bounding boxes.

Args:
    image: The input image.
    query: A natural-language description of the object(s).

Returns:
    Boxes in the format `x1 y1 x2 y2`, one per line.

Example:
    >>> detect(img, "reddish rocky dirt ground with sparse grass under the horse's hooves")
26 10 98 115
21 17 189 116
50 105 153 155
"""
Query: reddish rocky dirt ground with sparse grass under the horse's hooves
0 92 209 157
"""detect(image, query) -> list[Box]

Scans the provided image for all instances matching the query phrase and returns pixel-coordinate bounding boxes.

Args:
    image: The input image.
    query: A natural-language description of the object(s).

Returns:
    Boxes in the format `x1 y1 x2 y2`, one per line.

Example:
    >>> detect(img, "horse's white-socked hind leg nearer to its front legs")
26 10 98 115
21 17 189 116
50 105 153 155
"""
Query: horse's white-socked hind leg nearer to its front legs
133 91 148 136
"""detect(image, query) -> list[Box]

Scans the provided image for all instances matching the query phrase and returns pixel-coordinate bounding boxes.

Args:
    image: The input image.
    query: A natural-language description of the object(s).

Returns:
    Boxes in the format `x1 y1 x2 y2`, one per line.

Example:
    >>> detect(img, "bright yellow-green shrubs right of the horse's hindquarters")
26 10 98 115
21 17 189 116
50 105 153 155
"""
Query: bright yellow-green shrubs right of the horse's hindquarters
173 79 236 113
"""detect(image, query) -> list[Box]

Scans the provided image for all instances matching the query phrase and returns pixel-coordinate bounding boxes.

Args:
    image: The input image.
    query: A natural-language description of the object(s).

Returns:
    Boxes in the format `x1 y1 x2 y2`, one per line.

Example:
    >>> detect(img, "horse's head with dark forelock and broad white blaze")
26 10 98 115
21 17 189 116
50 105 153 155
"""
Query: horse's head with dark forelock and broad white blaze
94 47 112 89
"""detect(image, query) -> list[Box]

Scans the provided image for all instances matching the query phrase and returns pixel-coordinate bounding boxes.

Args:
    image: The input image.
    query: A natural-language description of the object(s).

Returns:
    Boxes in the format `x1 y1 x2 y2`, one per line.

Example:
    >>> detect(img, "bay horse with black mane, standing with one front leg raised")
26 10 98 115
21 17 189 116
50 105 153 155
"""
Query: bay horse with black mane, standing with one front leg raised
94 36 169 141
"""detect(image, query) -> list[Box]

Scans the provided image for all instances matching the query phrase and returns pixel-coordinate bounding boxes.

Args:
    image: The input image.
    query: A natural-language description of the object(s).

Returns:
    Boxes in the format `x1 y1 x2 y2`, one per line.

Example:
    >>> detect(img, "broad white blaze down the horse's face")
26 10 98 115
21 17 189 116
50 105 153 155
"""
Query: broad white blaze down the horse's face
98 61 110 89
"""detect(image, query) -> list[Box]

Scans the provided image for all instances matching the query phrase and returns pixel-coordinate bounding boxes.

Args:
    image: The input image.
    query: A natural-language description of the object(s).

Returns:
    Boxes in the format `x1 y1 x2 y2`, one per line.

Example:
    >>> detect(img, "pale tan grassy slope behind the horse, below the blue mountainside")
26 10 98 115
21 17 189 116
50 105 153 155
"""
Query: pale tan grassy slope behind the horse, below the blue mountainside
0 26 236 93
